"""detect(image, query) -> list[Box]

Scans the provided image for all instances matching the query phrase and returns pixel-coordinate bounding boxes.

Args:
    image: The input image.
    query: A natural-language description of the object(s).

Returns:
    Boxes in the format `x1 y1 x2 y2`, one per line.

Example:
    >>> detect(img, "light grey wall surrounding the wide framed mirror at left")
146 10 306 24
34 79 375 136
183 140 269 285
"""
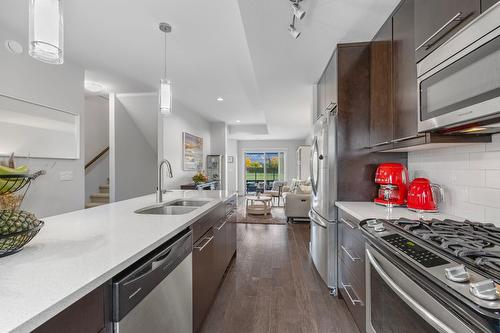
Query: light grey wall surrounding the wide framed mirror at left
0 27 85 217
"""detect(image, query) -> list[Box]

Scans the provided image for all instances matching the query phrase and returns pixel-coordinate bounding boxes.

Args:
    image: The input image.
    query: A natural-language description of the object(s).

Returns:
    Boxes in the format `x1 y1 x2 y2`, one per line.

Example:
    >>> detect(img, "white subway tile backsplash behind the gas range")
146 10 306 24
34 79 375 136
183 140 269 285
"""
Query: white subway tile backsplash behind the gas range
408 134 500 226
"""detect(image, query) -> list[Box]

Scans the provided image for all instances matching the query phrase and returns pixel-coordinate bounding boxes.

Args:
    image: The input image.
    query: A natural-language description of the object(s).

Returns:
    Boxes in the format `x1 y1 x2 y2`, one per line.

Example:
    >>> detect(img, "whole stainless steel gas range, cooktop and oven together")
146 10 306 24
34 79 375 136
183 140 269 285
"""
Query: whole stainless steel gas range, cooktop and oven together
361 219 500 332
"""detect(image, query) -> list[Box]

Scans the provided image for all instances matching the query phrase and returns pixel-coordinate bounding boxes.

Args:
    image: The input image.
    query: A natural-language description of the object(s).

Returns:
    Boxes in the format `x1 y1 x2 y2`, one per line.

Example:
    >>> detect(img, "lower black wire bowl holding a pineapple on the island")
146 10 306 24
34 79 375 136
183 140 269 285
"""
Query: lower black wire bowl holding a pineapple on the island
0 210 44 257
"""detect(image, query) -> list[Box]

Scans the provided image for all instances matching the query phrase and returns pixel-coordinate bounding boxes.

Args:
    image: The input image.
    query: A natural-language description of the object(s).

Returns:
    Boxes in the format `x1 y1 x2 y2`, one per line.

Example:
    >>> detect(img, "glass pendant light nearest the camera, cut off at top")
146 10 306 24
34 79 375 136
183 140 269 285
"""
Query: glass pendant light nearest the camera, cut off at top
29 0 64 64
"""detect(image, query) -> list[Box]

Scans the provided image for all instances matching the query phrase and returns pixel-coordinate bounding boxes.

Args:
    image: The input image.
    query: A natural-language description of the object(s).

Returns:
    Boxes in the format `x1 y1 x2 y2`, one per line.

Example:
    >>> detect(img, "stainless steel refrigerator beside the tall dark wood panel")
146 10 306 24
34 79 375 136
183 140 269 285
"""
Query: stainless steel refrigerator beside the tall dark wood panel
309 104 338 295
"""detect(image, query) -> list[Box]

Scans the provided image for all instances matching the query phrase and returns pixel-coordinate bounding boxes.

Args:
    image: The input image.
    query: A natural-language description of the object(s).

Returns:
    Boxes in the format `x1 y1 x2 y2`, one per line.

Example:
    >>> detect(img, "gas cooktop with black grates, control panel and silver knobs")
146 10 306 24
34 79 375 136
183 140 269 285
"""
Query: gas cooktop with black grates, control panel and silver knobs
361 218 500 312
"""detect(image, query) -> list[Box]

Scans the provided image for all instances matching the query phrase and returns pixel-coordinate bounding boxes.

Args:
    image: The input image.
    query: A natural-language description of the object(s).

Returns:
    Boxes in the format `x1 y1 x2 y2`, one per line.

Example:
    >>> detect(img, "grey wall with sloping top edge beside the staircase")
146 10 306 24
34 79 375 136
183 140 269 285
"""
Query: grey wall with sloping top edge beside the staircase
109 94 157 201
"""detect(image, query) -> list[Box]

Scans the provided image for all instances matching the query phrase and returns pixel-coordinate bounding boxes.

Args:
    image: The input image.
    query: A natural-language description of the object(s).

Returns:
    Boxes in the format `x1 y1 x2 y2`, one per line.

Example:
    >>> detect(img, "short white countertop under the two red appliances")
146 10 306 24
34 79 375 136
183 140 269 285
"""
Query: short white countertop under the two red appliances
335 201 464 221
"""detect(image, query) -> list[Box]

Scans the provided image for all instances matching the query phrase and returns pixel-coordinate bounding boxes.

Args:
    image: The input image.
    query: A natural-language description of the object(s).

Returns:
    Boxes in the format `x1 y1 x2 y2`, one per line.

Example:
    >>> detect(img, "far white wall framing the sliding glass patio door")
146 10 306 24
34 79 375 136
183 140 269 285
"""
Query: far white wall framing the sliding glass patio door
238 140 305 195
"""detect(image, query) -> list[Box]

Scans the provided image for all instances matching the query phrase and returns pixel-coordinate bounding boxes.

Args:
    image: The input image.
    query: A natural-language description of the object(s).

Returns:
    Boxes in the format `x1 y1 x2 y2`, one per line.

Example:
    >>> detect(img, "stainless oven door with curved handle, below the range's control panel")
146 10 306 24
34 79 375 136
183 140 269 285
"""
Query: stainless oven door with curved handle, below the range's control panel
366 244 474 333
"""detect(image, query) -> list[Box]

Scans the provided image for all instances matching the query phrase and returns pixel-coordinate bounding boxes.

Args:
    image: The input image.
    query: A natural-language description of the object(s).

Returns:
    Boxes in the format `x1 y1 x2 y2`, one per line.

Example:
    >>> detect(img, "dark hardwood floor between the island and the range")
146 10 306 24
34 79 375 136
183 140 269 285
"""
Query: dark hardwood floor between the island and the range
201 220 358 333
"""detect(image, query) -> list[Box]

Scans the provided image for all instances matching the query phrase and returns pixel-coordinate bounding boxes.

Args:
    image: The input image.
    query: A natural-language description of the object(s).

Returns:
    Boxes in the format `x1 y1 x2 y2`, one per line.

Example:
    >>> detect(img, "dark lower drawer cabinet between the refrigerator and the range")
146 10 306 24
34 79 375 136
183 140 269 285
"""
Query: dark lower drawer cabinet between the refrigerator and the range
337 210 366 332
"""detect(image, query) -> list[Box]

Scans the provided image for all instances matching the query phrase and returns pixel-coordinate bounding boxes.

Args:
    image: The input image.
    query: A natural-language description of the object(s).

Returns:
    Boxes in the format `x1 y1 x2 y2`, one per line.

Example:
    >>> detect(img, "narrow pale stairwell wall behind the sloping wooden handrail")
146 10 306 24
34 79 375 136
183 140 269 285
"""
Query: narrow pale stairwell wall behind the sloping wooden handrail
84 96 109 201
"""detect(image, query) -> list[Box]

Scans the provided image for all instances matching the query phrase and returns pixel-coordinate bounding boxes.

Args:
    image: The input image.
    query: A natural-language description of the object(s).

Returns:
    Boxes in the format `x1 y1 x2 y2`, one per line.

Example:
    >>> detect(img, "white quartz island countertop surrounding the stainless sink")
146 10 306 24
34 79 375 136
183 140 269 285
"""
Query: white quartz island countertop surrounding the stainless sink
0 191 232 332
